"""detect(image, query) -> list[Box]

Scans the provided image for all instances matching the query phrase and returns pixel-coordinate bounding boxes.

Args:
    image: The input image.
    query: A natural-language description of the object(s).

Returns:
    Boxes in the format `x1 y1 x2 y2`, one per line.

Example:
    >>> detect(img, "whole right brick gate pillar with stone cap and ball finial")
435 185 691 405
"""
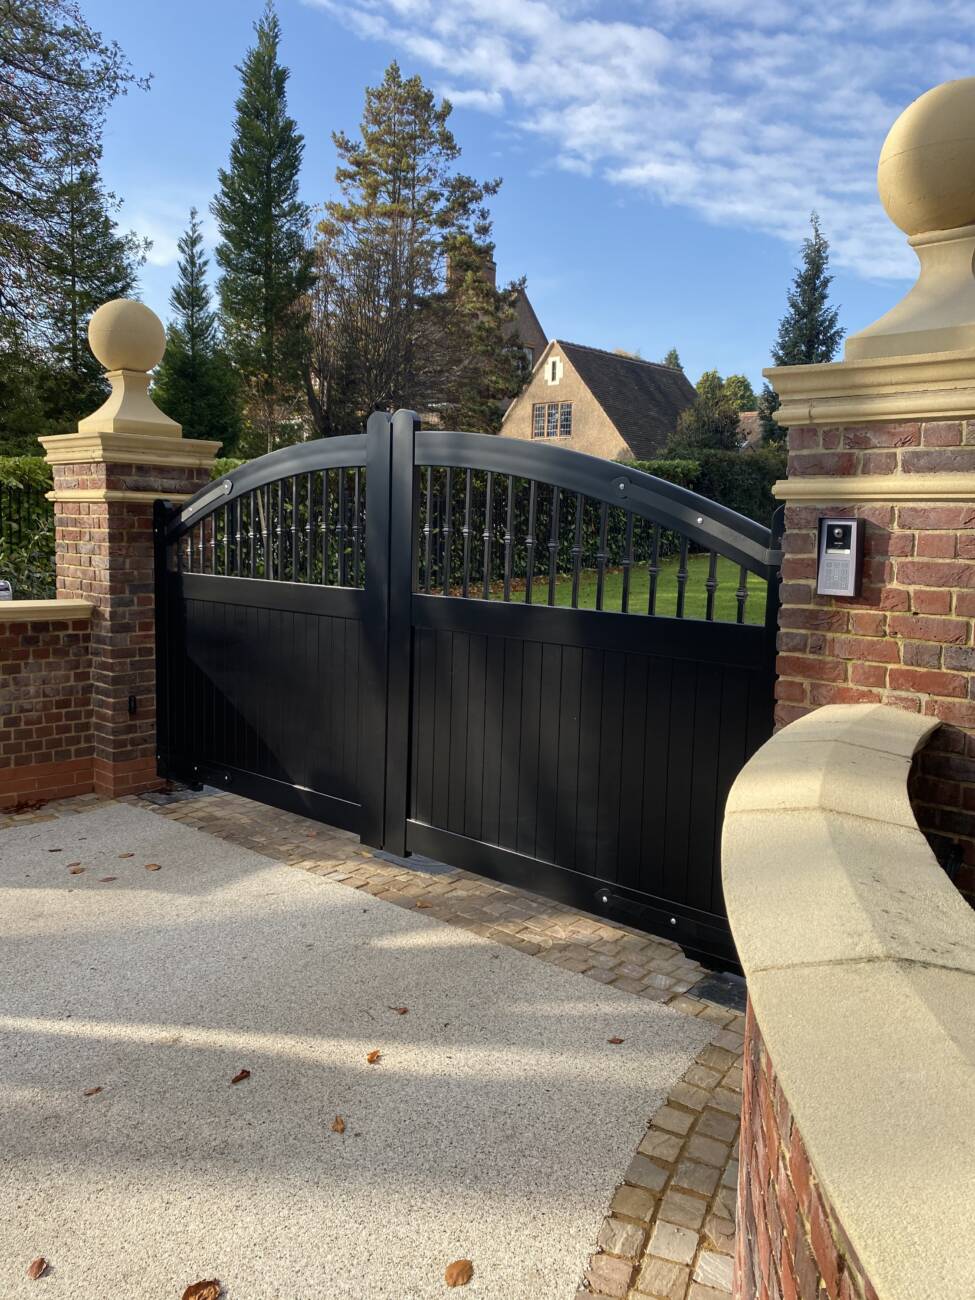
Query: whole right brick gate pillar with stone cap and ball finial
766 78 975 894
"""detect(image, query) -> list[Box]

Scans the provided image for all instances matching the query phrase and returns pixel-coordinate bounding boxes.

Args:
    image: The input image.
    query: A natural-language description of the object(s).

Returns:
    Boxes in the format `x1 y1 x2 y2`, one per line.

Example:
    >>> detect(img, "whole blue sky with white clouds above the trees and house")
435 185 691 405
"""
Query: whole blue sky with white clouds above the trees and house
82 0 975 385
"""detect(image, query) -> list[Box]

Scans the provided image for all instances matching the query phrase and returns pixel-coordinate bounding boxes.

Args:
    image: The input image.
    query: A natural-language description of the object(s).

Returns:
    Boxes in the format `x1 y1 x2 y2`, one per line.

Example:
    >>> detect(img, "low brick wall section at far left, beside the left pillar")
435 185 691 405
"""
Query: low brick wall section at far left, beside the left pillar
0 616 94 809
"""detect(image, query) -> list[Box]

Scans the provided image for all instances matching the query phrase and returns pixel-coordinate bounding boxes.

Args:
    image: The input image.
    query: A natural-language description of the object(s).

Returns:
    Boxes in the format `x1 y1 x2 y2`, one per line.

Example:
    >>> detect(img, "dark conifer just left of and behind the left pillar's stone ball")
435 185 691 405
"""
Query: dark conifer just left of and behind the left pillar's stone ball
38 139 151 426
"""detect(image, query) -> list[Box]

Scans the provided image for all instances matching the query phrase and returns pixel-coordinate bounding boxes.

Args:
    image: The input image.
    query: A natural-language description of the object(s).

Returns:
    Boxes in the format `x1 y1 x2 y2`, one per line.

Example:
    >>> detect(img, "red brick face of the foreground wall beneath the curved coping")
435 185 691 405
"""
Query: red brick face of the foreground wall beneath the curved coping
735 1006 878 1300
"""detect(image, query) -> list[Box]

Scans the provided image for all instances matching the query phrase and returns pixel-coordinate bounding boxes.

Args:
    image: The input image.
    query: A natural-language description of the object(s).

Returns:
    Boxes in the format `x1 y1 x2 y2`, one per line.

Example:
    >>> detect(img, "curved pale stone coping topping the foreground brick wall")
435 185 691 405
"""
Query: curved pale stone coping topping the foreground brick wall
723 705 975 1300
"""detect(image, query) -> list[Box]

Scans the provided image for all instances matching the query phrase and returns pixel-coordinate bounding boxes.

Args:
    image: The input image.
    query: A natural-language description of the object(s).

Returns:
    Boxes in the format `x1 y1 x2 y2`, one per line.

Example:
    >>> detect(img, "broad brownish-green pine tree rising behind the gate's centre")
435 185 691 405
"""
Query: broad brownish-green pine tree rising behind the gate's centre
308 62 527 433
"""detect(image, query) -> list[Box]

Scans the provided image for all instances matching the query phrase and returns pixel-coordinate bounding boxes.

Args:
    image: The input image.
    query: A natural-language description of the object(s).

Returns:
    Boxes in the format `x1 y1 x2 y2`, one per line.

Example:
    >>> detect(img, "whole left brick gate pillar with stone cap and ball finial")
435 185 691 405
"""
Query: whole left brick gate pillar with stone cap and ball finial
42 299 220 797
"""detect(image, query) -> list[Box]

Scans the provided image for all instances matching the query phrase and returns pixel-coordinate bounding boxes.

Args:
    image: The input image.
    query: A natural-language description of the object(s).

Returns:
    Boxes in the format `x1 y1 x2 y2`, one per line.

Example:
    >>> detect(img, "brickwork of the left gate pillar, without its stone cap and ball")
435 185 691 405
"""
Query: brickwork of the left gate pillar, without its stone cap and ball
53 463 209 797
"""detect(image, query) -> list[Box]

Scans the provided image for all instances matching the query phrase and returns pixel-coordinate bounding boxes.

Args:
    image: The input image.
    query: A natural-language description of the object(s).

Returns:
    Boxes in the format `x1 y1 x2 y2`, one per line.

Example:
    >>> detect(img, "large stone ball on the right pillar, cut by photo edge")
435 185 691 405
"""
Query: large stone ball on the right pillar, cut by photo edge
878 77 975 235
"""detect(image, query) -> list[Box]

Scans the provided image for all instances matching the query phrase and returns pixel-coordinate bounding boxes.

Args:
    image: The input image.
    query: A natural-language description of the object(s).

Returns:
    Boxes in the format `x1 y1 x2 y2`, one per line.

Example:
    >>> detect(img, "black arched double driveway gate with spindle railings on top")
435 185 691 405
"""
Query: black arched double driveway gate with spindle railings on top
156 411 780 962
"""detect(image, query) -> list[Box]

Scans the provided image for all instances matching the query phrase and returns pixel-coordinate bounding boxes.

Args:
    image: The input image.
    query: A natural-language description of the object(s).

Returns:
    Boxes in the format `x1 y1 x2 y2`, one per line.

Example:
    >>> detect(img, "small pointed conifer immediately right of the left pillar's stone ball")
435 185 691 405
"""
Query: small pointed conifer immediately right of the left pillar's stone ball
152 208 242 455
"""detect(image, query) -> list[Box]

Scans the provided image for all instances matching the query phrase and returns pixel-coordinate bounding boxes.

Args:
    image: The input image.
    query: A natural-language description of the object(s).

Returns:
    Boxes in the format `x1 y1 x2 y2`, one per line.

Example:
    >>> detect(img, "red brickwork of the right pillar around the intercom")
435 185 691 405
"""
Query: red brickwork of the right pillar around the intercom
776 420 975 894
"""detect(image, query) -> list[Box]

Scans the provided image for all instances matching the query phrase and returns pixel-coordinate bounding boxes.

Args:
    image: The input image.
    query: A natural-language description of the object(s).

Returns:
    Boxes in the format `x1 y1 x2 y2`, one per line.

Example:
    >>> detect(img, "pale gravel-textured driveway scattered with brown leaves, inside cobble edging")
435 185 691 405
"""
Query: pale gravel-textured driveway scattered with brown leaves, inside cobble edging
0 803 709 1300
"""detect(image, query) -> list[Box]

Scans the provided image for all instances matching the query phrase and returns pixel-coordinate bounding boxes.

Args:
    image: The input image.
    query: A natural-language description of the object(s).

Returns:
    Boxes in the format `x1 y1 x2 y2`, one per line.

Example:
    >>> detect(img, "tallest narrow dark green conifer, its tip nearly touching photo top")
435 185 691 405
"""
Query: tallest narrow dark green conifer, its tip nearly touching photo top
212 0 313 451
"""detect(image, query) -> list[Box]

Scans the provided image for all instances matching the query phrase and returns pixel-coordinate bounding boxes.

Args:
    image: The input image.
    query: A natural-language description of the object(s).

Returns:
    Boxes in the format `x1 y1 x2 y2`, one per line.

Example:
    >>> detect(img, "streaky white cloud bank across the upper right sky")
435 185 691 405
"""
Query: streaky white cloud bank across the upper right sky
307 0 975 278
